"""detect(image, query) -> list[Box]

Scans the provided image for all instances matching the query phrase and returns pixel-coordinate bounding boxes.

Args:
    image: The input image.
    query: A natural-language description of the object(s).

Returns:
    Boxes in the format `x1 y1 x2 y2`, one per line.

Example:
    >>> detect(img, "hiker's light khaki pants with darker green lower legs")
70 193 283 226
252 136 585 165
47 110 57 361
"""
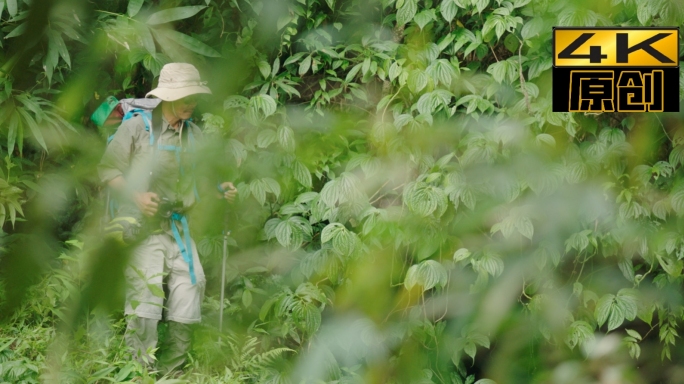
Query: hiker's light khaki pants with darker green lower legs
125 233 206 374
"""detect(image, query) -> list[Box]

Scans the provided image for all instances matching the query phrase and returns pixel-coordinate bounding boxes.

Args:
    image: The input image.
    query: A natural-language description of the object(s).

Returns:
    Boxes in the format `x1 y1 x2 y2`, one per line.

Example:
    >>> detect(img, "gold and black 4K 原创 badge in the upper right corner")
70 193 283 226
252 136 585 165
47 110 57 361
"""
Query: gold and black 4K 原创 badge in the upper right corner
553 27 679 113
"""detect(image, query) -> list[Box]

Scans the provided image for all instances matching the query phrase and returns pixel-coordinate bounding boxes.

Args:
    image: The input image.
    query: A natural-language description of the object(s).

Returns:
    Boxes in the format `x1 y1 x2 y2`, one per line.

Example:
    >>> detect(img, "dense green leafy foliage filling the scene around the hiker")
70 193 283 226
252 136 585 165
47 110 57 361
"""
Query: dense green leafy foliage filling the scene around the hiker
0 0 684 384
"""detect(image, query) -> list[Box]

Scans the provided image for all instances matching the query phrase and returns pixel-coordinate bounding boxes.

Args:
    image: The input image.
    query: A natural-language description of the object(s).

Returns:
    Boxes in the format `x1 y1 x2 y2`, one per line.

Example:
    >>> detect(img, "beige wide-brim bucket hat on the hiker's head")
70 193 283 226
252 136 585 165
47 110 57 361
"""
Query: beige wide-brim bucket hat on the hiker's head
145 63 211 101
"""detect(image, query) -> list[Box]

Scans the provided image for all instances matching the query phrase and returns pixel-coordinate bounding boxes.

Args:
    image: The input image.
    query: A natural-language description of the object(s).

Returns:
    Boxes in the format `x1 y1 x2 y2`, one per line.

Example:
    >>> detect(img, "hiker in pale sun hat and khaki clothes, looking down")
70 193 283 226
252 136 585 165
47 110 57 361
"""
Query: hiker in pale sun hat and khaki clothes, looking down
98 63 237 374
